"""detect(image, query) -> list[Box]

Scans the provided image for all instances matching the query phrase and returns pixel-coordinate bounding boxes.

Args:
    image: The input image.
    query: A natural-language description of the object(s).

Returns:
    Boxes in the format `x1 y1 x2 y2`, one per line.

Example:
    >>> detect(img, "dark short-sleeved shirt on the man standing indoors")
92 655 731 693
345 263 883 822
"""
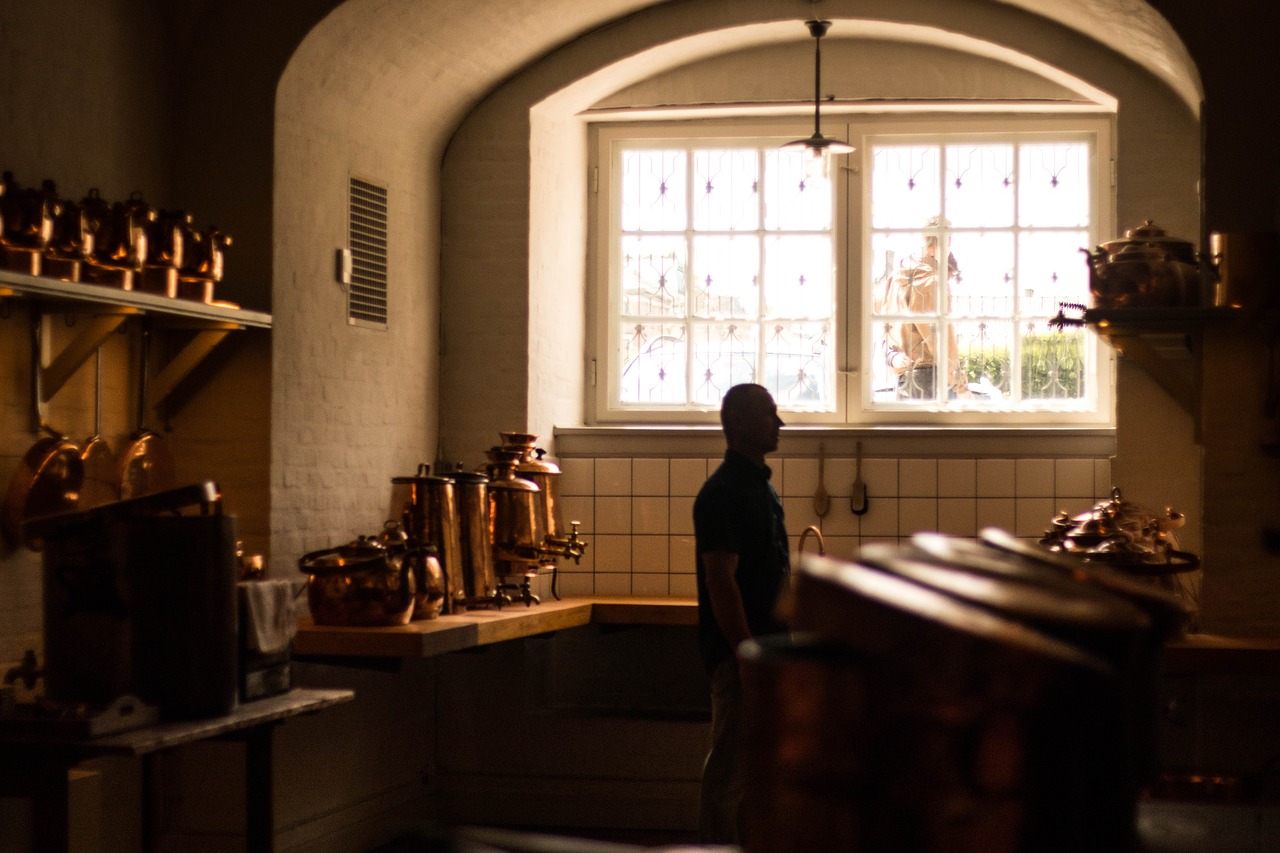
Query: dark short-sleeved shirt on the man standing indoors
694 451 791 672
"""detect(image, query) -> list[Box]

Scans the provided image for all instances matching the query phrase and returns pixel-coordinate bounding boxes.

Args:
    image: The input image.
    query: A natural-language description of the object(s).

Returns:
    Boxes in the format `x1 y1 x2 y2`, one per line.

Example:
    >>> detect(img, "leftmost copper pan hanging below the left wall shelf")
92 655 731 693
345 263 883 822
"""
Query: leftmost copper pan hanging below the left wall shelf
3 428 84 551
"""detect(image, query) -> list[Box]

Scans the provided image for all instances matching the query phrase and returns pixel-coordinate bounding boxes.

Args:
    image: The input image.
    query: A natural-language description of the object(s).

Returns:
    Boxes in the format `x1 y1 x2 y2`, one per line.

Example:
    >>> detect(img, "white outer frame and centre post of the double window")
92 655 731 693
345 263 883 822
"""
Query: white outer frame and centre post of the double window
586 113 1115 428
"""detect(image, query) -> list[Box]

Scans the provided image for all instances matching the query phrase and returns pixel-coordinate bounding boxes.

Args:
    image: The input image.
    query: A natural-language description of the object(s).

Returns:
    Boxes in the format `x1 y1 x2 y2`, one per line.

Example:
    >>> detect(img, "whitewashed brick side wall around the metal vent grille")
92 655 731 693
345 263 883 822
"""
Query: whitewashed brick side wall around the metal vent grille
271 4 450 567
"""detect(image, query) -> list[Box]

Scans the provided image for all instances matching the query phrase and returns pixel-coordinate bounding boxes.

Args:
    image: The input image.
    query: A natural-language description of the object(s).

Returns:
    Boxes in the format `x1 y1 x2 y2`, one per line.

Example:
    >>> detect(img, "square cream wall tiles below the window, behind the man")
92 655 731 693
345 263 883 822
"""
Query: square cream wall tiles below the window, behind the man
557 456 1111 596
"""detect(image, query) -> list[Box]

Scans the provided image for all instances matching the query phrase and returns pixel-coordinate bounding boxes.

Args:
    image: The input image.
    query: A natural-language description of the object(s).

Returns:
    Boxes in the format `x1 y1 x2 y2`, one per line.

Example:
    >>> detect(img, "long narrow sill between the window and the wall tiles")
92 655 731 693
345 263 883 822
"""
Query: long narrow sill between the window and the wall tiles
556 425 1116 459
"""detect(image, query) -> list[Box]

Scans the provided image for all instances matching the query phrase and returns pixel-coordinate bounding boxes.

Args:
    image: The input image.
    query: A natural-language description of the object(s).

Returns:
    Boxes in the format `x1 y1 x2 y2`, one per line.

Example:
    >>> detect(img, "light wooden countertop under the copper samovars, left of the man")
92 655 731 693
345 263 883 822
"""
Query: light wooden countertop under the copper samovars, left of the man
293 596 698 657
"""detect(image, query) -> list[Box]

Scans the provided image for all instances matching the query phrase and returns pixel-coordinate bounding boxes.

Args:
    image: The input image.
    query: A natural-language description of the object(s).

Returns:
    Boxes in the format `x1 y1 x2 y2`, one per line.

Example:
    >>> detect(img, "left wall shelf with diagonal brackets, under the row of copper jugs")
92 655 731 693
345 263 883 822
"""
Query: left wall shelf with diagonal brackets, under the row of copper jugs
0 270 271 432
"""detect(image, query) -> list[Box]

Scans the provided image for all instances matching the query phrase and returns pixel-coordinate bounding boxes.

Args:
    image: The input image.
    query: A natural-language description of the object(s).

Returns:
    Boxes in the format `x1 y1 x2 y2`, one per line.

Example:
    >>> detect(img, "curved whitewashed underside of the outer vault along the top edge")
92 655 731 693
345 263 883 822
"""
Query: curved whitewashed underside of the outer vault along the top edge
282 0 1202 142
